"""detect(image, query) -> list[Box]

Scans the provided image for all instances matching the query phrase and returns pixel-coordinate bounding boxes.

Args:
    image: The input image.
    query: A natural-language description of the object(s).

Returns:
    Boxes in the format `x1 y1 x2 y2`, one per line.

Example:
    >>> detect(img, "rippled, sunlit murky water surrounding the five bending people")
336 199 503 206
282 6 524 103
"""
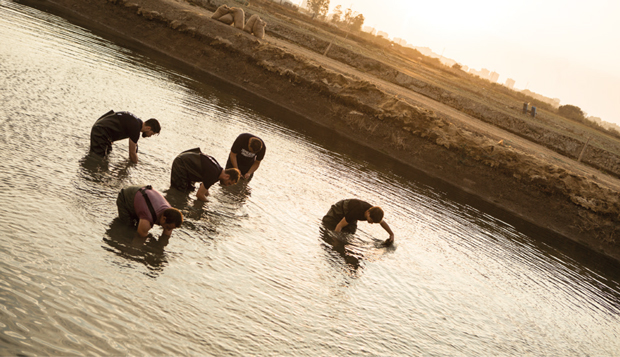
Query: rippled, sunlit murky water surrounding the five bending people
0 0 620 356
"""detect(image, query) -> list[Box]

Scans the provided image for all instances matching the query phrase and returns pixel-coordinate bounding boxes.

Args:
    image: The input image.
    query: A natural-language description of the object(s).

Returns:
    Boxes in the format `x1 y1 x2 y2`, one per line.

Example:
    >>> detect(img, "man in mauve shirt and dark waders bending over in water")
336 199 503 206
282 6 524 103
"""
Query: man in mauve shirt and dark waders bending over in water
116 185 183 242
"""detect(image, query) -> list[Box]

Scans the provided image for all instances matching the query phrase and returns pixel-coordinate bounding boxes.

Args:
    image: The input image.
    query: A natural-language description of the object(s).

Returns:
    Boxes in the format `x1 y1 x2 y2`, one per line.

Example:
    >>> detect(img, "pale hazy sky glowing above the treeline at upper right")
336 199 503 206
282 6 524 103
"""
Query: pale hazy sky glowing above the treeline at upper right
320 0 620 125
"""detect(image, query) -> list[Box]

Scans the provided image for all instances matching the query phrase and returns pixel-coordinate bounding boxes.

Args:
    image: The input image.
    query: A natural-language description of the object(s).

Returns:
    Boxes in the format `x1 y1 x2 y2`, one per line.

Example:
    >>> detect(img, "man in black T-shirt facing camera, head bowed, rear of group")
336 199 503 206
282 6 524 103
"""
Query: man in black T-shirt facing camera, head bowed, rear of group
226 133 267 180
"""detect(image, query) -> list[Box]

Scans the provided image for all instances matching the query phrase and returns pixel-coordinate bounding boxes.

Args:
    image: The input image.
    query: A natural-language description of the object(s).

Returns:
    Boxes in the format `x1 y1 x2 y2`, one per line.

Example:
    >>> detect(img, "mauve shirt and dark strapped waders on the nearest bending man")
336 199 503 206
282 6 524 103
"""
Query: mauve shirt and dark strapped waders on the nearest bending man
116 185 172 227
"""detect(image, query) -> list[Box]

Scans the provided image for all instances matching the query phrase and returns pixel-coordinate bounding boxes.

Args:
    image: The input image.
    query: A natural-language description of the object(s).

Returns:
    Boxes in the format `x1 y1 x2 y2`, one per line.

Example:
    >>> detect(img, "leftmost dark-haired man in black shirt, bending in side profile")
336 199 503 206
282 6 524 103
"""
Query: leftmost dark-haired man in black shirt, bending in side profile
90 110 161 163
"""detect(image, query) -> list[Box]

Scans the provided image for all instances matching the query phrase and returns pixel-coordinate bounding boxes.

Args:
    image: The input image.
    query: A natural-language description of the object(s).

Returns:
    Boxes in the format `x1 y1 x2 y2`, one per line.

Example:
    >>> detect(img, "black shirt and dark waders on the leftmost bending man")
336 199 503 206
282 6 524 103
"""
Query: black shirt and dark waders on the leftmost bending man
90 110 142 156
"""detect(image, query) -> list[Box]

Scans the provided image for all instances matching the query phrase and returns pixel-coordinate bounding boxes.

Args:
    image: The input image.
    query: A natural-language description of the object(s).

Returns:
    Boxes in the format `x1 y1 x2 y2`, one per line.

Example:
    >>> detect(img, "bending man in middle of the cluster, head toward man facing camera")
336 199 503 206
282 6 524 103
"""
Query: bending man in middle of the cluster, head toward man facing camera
170 148 241 202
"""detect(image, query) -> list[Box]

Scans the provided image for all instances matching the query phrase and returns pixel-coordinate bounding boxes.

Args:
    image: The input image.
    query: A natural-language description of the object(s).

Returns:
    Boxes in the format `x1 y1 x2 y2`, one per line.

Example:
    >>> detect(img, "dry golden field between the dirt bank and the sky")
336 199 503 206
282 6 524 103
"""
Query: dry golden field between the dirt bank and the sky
199 0 620 177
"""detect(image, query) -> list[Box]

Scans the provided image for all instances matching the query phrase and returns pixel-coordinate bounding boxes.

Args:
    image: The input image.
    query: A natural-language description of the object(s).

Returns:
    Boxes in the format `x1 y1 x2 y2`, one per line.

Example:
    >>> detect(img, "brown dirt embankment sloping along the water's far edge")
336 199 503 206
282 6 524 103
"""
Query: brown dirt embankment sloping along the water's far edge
26 0 620 260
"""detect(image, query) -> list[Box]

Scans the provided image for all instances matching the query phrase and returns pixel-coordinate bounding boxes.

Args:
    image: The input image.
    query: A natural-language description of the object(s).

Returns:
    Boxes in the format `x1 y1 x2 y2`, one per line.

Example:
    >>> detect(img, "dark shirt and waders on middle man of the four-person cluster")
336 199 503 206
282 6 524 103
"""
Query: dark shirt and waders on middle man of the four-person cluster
170 148 223 191
